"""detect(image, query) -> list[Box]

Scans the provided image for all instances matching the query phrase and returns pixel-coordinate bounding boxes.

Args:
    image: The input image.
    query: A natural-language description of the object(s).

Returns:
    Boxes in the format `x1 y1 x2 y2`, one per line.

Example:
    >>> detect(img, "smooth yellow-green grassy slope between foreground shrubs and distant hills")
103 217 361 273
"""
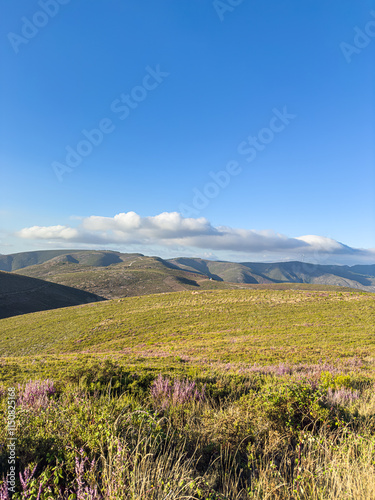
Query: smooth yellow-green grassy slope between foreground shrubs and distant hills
0 290 375 364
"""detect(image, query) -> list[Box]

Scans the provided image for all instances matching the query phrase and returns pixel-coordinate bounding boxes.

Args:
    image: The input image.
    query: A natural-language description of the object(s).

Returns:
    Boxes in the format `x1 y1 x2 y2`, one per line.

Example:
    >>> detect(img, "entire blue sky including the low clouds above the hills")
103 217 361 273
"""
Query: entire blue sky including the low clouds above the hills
0 0 375 263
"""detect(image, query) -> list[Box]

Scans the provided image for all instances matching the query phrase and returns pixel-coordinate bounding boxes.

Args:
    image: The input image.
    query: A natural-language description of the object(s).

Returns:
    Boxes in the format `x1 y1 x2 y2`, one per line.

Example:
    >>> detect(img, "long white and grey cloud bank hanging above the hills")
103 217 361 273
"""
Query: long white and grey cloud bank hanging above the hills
17 212 375 262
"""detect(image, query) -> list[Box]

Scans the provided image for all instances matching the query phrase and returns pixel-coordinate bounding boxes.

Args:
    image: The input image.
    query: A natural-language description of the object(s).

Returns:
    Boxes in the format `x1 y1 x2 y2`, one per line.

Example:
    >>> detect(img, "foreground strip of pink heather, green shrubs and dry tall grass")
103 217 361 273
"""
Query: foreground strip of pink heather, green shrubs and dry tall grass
0 360 375 500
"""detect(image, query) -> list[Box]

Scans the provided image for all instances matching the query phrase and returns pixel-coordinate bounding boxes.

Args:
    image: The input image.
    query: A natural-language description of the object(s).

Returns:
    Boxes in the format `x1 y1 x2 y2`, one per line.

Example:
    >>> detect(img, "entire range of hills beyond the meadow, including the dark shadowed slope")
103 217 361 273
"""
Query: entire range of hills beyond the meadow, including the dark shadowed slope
0 250 375 318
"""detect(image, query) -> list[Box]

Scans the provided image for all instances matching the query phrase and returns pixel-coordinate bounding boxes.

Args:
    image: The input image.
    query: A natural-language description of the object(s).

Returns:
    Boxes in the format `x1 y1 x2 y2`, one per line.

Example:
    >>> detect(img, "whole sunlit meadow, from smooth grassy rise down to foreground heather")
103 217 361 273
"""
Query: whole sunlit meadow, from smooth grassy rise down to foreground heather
0 286 375 500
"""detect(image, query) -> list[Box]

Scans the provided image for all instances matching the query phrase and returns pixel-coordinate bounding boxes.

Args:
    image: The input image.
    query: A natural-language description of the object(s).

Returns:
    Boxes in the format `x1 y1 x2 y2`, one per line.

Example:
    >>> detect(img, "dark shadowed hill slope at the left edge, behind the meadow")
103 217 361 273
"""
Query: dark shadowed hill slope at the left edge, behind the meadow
0 271 105 318
